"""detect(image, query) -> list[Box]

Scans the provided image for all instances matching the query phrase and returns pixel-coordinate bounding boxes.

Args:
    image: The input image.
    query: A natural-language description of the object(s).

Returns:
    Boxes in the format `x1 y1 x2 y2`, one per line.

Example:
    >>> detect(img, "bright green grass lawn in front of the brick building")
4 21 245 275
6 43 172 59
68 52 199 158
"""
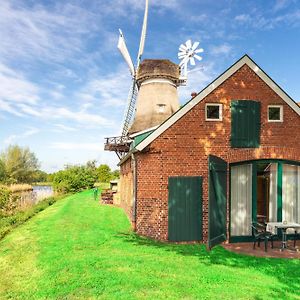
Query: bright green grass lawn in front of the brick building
0 191 300 299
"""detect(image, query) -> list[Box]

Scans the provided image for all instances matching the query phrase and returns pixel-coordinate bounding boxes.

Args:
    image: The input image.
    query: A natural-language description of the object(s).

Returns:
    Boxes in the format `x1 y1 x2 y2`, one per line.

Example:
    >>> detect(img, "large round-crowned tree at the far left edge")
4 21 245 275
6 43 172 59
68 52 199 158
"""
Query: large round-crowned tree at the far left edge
1 145 39 183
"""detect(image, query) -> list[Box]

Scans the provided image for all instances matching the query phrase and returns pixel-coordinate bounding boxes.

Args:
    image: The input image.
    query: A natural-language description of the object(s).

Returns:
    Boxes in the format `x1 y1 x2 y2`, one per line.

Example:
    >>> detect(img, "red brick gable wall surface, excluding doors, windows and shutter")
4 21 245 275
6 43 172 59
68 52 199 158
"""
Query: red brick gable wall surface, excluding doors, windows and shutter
132 65 300 241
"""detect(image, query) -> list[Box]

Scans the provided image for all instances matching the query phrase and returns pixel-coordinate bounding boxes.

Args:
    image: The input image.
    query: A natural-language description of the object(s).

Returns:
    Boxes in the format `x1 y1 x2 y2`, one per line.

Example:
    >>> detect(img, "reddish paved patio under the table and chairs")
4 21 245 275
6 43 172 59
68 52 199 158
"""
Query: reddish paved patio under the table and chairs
222 241 300 259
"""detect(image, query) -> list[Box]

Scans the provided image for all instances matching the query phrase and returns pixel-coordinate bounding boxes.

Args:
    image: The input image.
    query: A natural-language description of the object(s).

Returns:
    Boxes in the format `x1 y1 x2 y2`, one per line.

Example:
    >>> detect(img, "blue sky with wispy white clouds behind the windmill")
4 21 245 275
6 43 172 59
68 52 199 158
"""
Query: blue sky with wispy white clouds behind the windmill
0 0 300 172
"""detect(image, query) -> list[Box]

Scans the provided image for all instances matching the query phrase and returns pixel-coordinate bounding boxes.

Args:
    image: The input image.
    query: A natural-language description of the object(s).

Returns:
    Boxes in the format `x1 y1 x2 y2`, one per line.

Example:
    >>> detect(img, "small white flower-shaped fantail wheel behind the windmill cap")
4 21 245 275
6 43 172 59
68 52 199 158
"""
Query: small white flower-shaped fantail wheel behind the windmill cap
178 40 204 85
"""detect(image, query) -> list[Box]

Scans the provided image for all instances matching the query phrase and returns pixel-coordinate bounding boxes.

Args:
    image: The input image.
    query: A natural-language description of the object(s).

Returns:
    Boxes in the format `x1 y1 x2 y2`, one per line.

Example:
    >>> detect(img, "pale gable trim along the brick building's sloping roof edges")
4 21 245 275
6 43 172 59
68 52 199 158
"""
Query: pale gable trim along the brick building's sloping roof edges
135 54 300 151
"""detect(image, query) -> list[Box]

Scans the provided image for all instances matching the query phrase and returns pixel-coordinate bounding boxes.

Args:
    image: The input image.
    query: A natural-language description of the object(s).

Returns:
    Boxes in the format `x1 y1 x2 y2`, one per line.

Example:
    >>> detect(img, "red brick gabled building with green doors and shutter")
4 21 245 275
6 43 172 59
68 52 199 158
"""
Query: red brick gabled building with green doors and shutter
120 55 300 246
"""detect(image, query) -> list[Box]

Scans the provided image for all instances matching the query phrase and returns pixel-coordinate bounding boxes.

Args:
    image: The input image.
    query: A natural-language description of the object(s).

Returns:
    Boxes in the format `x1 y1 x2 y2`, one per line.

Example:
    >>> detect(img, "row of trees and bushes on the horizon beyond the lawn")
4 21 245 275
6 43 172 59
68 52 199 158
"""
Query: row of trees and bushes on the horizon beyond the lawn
0 145 120 193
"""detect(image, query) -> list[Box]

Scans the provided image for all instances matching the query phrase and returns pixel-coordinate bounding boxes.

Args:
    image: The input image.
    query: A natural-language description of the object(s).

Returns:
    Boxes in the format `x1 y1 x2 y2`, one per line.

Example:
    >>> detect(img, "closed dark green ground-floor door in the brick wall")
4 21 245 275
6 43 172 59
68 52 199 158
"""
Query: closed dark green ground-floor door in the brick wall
168 177 202 242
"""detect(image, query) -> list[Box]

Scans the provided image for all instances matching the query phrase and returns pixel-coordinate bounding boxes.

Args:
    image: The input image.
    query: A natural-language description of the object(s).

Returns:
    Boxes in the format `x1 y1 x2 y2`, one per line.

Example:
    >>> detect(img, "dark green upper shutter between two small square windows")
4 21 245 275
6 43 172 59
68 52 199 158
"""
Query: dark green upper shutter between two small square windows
231 100 260 148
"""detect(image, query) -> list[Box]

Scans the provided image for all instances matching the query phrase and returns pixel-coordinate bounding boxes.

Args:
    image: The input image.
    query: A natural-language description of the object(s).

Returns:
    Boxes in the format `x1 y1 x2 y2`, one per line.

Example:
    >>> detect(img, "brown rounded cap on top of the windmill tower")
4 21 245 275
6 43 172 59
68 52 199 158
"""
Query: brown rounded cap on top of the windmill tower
137 59 180 84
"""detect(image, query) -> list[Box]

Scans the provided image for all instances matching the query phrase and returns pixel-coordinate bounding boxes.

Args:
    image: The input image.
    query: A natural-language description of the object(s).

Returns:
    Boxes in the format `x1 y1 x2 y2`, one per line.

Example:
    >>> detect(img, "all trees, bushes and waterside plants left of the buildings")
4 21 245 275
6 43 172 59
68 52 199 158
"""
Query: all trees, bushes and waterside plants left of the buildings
0 145 119 239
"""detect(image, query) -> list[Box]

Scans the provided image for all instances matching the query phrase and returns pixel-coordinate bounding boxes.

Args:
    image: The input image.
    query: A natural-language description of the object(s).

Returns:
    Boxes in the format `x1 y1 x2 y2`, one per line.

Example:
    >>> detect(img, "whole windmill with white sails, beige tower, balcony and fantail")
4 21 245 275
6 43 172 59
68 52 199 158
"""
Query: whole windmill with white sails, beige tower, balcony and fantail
104 0 203 159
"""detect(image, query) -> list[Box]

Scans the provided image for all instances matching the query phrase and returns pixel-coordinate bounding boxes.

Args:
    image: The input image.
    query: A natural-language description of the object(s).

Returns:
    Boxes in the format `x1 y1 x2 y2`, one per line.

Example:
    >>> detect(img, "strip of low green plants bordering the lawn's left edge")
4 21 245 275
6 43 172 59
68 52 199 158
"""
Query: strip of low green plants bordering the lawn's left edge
0 195 66 240
